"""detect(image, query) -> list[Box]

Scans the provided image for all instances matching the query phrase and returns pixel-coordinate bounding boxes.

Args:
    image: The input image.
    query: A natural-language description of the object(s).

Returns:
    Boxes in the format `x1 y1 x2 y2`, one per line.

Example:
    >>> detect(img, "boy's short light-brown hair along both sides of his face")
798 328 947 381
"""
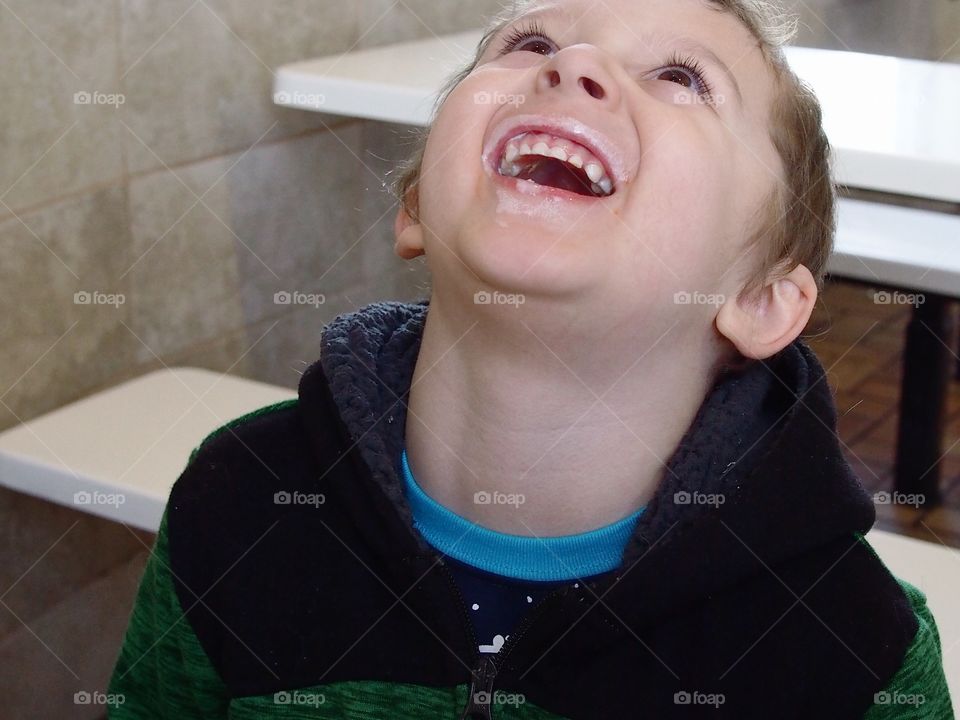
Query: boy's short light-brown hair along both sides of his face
392 0 836 293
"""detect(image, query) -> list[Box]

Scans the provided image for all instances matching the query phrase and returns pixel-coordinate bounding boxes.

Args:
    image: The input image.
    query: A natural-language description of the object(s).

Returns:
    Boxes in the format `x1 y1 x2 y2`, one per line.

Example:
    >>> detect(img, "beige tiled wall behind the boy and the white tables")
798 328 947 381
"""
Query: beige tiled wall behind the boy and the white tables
0 0 960 718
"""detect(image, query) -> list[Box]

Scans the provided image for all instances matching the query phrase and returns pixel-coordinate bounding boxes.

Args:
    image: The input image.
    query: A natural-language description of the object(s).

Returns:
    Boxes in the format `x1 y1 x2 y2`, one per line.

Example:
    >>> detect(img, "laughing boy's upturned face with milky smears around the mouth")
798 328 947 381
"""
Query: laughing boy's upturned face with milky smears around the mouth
401 0 781 340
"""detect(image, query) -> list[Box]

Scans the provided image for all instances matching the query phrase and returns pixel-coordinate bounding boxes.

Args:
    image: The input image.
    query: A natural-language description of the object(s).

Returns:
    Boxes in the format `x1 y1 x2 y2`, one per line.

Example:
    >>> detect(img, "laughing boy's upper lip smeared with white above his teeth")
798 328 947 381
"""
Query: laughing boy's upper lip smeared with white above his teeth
483 114 628 188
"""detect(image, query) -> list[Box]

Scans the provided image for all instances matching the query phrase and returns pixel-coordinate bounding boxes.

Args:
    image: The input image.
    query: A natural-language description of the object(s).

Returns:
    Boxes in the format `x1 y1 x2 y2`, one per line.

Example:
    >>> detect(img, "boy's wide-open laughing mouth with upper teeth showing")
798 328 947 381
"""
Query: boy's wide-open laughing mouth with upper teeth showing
497 131 616 198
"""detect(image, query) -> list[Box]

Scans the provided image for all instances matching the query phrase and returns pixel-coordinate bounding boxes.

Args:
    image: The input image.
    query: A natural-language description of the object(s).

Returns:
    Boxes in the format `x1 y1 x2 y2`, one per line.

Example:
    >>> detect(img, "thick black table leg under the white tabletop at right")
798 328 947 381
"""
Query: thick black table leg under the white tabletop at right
894 294 953 505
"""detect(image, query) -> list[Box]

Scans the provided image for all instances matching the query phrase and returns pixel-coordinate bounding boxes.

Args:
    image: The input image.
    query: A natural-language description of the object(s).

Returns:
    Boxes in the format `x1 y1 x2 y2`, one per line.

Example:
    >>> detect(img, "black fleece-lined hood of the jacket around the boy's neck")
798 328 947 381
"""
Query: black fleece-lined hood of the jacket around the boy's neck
310 300 875 621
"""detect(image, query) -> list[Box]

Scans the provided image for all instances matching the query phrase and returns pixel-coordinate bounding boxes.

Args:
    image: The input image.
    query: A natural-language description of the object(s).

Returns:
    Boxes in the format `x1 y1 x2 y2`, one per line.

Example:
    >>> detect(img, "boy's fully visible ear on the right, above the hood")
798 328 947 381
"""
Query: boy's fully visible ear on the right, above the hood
716 265 817 360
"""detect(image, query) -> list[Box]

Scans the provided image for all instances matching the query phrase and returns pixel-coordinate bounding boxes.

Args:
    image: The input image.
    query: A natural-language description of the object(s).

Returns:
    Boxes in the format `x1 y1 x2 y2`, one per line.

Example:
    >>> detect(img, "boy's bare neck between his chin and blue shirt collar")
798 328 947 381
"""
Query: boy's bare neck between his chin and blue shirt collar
405 293 715 537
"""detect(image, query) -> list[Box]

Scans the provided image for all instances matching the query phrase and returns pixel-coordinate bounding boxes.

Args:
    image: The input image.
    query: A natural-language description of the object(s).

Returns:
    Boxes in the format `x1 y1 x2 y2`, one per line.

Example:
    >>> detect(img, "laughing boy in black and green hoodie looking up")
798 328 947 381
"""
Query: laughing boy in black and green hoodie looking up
110 0 952 720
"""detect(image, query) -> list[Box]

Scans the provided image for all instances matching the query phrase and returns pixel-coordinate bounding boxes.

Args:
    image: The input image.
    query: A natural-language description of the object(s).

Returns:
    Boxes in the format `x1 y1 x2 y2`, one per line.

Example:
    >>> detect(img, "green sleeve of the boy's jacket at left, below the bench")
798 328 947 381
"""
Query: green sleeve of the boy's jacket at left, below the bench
107 505 229 720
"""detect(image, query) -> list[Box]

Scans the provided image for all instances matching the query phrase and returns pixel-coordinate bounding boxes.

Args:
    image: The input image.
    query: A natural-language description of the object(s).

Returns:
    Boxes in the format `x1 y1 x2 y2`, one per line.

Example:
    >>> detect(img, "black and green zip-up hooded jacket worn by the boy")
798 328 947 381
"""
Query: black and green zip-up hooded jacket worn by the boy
108 300 953 720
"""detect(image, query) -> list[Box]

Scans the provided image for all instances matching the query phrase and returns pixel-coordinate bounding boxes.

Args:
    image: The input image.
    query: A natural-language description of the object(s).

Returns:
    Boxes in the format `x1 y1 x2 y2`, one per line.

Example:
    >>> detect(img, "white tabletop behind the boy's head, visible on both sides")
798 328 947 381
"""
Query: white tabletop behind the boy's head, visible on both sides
273 30 960 202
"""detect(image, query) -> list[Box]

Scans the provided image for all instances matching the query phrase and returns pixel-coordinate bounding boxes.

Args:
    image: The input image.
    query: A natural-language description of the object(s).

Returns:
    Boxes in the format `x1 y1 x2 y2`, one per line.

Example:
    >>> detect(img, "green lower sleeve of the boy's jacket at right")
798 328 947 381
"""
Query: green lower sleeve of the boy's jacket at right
864 578 954 720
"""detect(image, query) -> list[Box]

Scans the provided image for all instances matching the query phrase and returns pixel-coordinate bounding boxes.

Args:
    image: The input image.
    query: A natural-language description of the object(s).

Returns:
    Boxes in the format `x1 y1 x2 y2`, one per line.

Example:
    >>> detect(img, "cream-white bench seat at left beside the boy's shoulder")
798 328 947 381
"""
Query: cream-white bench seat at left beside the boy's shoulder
0 368 296 532
